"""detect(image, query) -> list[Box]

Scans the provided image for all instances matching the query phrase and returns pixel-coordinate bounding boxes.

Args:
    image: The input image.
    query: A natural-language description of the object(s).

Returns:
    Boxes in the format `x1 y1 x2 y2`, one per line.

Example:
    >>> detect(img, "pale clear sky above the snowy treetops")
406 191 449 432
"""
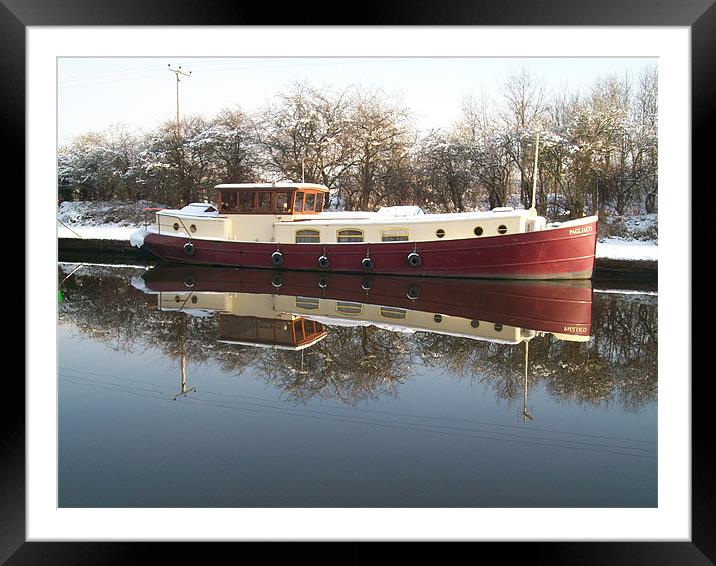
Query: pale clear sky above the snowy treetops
57 57 656 145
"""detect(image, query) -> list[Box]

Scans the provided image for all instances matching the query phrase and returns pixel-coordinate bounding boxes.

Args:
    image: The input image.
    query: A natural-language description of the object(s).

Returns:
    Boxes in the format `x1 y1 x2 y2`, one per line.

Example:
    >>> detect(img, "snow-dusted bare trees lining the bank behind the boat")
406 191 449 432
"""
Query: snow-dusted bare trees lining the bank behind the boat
58 67 658 222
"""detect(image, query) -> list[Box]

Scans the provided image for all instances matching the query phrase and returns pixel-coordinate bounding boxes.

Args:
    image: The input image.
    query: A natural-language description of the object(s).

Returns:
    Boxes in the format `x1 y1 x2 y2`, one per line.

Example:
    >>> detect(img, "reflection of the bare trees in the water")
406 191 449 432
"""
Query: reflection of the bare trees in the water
59 267 658 411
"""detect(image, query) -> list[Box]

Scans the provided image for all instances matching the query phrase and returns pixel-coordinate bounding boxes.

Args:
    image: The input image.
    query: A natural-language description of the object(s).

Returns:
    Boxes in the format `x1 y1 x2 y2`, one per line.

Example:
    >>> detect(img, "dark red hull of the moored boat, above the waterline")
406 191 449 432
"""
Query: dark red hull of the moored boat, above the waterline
143 221 597 279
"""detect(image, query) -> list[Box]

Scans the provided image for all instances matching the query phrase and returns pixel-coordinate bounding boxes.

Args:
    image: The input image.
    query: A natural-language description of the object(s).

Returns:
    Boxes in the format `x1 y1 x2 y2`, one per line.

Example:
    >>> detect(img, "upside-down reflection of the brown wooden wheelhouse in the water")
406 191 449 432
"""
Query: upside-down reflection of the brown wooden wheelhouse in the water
219 313 326 350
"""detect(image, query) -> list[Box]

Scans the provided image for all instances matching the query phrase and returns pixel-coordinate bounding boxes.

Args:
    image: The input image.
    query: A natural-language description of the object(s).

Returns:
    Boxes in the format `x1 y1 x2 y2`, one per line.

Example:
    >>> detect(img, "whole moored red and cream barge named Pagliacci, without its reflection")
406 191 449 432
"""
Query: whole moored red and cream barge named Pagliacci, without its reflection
130 183 597 279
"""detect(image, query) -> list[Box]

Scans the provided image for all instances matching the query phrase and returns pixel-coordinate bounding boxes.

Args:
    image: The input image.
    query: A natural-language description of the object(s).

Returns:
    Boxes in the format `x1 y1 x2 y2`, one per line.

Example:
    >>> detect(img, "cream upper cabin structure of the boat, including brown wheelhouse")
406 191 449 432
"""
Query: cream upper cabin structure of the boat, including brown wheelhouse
149 183 546 244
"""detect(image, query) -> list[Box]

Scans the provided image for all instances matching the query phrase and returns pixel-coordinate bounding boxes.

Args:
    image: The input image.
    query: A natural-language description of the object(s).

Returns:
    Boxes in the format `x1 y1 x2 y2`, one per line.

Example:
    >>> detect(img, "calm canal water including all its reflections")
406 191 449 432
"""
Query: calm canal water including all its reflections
58 264 658 507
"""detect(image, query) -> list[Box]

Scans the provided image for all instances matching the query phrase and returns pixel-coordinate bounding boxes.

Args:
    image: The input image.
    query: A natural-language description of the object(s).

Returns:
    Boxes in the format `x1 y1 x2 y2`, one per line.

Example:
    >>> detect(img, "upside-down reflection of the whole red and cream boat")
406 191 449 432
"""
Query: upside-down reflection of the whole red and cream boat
132 266 592 420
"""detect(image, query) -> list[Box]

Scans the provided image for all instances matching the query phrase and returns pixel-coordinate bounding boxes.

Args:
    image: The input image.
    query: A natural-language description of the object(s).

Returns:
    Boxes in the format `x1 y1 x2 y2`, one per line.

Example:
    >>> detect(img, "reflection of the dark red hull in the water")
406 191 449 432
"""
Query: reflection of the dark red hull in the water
143 266 592 336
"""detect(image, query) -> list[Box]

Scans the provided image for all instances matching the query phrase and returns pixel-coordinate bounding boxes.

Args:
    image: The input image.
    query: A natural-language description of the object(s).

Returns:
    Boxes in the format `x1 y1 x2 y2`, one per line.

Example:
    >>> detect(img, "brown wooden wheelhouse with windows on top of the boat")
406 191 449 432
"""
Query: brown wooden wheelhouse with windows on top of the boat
216 183 328 214
